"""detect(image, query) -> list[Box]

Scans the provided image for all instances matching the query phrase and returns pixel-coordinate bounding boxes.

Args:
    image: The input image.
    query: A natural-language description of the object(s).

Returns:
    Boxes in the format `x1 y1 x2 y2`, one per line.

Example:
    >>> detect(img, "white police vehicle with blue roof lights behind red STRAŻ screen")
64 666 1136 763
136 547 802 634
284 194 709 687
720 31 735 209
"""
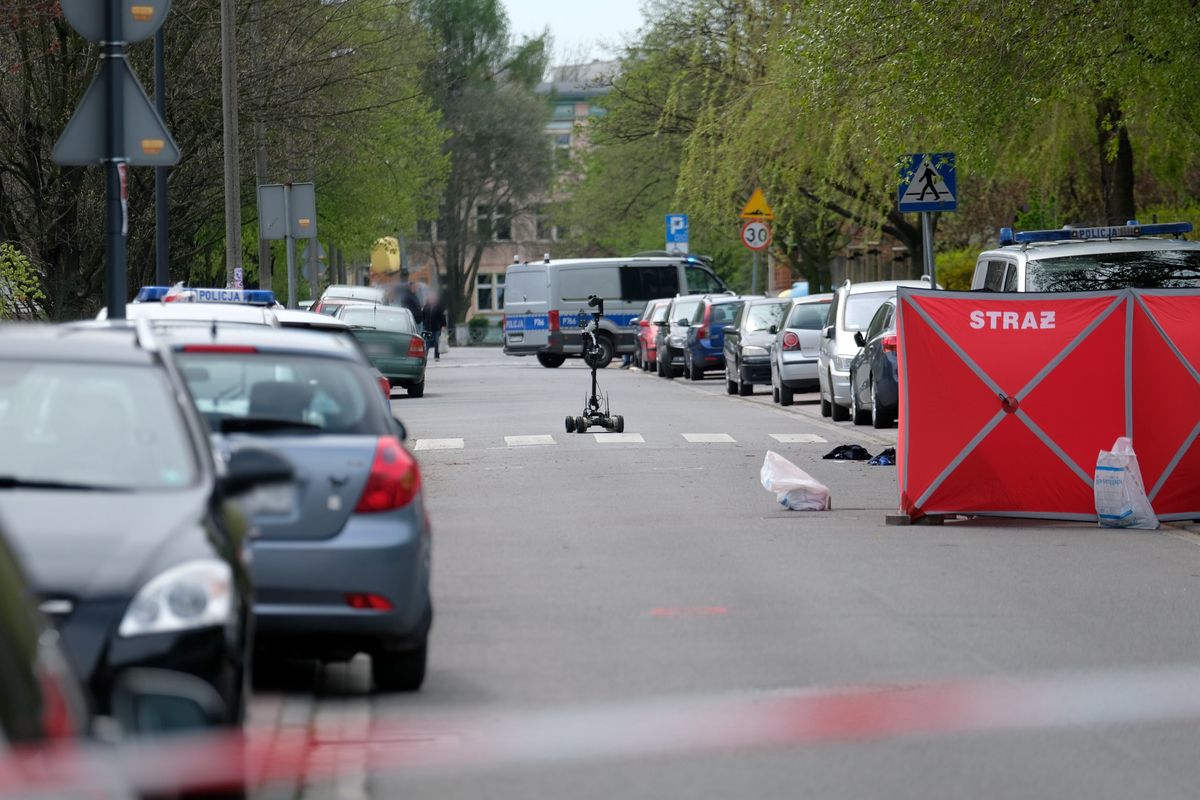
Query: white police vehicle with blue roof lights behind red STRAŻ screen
971 219 1200 291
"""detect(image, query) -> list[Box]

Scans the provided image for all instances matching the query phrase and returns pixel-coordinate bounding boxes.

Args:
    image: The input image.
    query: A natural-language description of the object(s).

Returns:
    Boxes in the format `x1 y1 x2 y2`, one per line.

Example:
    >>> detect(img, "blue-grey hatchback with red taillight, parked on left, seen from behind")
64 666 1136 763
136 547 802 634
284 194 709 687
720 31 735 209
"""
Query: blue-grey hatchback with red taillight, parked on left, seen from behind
170 327 433 691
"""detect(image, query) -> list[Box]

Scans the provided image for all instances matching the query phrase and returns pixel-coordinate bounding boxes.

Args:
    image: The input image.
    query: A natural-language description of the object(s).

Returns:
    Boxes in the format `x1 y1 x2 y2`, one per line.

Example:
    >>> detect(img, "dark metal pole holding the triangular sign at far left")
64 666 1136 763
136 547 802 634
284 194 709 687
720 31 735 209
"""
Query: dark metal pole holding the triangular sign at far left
102 0 128 319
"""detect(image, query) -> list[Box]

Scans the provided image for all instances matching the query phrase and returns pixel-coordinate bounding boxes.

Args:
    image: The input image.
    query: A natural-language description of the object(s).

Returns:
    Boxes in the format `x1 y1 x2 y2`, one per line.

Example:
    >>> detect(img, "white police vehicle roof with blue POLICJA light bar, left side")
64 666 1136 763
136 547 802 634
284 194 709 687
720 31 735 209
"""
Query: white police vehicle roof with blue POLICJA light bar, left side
96 284 282 327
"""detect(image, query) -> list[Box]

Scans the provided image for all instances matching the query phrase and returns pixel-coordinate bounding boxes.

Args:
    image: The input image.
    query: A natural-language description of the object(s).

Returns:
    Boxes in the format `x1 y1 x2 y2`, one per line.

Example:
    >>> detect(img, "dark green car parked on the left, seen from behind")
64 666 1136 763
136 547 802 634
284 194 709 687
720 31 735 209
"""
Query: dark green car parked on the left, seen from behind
337 305 426 397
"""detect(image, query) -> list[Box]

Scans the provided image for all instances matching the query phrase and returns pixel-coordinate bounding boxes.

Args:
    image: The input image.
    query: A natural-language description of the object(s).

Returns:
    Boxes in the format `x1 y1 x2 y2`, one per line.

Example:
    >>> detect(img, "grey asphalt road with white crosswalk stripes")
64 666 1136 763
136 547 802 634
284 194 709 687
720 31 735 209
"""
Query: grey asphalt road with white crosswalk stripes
252 349 1200 800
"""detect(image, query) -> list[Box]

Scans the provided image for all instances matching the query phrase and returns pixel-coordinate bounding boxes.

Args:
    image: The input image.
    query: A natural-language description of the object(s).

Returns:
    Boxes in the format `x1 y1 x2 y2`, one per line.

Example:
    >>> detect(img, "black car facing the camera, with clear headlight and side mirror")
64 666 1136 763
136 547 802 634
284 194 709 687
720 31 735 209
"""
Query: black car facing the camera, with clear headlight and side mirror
0 323 292 729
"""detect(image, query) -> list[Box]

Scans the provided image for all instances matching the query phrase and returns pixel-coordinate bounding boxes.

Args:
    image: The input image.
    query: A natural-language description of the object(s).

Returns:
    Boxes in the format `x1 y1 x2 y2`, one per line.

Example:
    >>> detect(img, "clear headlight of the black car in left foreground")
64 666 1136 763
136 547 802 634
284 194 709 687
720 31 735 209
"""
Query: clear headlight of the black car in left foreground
118 559 233 637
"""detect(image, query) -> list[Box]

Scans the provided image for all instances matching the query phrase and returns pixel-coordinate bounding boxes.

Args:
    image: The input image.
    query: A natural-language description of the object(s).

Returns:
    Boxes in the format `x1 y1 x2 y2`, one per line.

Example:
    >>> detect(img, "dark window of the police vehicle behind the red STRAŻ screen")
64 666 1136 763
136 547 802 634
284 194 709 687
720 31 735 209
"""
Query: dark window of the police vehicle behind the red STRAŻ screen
1025 249 1200 291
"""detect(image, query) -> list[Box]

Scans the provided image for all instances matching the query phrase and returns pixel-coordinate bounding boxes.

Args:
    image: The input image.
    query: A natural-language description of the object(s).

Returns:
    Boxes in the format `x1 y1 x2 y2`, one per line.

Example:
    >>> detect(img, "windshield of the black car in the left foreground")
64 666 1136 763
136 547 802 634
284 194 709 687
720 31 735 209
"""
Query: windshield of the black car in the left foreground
0 361 197 491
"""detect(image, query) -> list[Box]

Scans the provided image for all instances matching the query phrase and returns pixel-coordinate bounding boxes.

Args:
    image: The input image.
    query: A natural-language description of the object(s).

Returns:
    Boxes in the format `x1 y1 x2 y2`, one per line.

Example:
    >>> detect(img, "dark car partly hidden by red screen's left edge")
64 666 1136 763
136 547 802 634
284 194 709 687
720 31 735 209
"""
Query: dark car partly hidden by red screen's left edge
850 295 900 428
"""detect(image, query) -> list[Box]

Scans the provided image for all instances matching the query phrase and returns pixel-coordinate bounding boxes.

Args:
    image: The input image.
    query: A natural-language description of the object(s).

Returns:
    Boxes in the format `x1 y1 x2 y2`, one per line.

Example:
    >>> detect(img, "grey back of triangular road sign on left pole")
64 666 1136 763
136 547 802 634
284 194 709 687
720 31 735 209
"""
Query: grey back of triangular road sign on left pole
52 59 179 167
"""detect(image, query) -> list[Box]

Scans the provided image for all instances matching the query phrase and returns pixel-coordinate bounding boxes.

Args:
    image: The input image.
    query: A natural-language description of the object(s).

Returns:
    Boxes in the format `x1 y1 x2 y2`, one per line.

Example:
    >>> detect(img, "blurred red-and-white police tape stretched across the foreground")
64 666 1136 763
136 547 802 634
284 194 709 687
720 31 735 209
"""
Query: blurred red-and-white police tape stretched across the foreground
7 667 1200 798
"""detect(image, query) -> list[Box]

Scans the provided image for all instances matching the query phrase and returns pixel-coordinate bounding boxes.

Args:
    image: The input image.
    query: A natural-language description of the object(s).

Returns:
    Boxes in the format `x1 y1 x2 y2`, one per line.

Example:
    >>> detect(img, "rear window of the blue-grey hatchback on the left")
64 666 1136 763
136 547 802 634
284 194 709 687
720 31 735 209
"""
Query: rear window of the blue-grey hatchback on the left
179 351 388 435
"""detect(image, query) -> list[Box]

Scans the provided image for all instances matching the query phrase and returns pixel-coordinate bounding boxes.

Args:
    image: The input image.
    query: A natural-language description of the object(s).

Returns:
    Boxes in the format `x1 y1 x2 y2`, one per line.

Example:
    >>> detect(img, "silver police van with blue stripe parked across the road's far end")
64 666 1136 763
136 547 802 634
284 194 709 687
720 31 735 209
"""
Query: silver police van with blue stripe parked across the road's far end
504 255 727 367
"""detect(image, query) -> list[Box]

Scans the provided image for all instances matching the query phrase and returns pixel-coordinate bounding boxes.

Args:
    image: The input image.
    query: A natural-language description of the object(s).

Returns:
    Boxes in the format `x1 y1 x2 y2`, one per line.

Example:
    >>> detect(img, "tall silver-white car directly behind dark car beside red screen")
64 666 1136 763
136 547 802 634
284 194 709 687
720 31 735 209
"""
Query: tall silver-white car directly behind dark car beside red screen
817 279 930 421
